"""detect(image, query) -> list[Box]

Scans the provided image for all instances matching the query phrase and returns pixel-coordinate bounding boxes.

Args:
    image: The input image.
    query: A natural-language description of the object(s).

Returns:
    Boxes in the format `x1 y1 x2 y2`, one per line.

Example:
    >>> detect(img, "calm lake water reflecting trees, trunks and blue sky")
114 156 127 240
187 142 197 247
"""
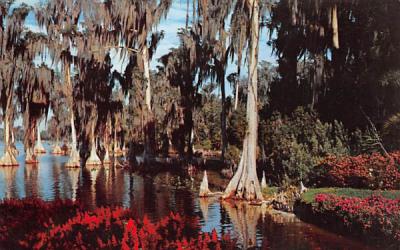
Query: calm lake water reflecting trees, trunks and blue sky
0 142 380 249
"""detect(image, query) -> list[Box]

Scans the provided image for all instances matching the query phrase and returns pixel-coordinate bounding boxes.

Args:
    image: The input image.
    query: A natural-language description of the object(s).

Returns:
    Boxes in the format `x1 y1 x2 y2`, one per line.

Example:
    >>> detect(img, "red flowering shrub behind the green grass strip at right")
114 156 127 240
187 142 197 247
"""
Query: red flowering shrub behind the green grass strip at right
310 152 400 189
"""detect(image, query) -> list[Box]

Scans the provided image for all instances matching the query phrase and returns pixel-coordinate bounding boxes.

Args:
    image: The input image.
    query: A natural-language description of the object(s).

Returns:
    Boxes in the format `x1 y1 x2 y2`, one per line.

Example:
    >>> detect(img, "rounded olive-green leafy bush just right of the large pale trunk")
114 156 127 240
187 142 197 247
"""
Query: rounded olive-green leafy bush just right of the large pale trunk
260 107 350 183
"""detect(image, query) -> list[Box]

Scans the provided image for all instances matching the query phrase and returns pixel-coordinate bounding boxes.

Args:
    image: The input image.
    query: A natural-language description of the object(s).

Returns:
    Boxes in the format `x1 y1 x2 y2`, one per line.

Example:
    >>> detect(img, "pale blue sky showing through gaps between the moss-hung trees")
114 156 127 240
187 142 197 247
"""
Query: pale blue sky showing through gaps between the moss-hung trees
14 0 276 128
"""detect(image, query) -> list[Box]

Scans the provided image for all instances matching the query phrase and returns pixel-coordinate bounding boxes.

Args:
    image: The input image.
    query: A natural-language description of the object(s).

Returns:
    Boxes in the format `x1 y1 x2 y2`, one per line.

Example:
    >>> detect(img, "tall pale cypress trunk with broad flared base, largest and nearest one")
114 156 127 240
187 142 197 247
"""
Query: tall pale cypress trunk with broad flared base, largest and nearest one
224 0 263 200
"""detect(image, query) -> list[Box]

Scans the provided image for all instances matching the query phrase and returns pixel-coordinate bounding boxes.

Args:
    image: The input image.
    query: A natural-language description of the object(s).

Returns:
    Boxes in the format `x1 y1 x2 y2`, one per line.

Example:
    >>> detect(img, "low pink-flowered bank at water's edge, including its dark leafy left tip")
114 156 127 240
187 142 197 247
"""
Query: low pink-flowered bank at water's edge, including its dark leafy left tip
295 193 400 245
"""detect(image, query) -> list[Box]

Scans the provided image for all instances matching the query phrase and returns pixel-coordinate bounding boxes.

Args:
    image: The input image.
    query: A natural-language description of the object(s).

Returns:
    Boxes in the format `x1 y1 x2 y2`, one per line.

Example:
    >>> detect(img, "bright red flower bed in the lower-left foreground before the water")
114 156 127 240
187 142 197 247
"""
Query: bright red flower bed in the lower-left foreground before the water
0 200 236 249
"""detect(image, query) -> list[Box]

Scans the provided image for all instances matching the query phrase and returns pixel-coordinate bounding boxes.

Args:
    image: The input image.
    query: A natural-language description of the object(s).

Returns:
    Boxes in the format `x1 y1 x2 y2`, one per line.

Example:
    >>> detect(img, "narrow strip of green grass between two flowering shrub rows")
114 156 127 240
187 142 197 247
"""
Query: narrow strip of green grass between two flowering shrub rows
301 188 400 203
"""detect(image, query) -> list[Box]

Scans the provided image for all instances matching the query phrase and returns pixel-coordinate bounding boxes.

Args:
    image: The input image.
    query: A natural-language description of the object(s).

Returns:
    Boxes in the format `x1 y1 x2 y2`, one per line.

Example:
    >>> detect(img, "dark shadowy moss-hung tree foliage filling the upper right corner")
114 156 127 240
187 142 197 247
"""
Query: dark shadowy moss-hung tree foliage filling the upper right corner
269 0 400 130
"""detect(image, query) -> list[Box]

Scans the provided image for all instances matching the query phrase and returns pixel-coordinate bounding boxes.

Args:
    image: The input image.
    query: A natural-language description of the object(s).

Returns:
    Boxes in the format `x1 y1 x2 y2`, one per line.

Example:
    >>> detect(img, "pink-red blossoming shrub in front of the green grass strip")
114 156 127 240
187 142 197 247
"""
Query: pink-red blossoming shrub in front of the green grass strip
312 194 400 241
